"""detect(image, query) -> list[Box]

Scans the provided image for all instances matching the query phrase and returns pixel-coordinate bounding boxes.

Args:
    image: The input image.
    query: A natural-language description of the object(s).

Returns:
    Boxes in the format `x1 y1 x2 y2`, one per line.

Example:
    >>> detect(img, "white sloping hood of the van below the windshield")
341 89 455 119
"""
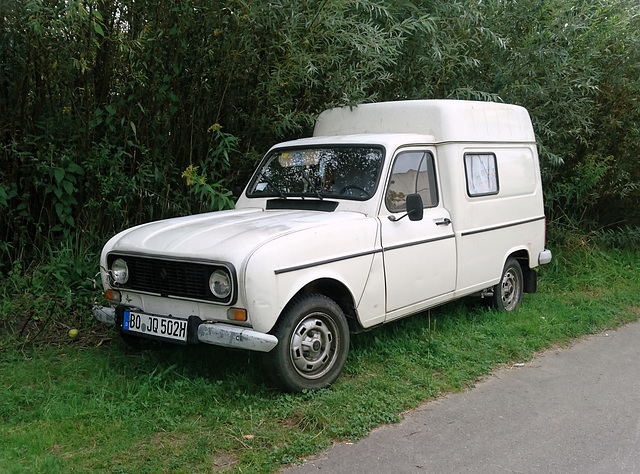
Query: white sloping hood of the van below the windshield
103 209 366 264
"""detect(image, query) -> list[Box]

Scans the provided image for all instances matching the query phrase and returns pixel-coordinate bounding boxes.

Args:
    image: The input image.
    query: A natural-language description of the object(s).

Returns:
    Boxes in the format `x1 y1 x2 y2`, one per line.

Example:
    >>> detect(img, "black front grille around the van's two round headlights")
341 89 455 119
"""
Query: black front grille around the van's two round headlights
108 254 235 303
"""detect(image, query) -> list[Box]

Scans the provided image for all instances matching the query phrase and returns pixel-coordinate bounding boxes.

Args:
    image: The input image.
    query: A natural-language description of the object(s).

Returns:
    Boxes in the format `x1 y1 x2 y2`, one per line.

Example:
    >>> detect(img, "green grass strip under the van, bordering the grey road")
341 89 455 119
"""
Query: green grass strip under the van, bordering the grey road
0 249 640 473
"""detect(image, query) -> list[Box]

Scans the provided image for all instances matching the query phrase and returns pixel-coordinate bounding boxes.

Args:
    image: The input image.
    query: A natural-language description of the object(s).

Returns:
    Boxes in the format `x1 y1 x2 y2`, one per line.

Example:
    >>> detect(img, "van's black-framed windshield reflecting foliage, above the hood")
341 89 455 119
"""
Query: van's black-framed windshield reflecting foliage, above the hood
248 146 383 200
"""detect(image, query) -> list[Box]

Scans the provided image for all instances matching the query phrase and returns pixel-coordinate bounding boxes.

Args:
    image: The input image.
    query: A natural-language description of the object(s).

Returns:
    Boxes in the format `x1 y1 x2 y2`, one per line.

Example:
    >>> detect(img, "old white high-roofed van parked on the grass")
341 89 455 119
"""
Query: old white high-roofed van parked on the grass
95 100 551 391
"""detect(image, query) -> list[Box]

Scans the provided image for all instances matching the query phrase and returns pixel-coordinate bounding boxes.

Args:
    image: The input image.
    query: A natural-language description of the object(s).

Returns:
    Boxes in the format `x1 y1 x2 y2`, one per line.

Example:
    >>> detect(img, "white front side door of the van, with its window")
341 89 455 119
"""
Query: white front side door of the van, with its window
380 149 456 319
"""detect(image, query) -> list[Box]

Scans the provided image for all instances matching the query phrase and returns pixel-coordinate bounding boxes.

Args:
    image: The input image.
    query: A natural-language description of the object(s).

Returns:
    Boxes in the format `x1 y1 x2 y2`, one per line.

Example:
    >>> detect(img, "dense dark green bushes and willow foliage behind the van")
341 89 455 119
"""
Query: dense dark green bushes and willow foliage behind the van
0 0 640 274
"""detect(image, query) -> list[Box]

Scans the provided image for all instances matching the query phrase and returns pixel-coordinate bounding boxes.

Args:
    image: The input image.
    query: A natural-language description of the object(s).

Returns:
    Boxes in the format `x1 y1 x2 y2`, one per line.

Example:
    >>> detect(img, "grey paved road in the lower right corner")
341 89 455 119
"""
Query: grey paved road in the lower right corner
284 323 640 474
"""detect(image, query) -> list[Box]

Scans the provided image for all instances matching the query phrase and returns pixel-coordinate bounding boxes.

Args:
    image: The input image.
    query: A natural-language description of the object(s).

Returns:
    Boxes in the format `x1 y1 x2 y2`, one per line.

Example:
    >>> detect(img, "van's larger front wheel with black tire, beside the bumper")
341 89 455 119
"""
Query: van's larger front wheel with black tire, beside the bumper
267 295 349 392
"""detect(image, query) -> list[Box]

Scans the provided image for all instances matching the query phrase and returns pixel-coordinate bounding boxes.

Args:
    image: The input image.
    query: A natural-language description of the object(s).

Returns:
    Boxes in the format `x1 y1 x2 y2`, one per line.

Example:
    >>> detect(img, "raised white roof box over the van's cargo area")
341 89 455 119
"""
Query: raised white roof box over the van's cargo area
313 99 535 143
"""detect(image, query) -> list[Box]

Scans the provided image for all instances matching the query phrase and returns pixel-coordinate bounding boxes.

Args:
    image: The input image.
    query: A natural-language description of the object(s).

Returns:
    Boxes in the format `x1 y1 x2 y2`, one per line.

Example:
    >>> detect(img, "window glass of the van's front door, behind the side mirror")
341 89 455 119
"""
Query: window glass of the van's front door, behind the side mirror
385 151 438 212
